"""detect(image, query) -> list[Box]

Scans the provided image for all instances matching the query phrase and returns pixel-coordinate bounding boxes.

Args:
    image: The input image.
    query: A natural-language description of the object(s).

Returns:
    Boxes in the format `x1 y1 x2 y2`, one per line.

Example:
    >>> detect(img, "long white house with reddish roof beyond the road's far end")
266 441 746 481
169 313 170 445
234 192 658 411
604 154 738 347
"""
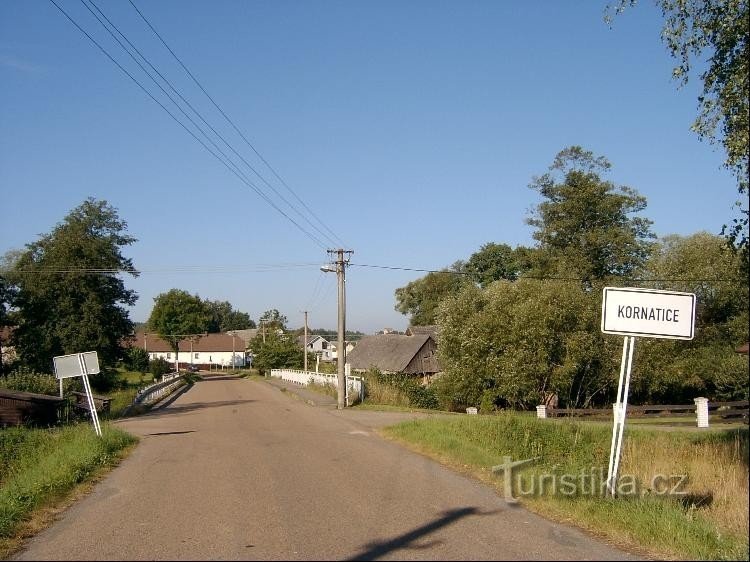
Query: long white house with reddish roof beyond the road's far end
127 331 247 369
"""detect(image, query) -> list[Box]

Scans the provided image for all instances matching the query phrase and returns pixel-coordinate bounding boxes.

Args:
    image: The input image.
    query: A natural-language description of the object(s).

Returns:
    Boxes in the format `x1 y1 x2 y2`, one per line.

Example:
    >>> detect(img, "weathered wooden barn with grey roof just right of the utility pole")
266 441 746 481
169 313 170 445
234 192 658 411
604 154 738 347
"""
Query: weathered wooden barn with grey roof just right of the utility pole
347 334 440 382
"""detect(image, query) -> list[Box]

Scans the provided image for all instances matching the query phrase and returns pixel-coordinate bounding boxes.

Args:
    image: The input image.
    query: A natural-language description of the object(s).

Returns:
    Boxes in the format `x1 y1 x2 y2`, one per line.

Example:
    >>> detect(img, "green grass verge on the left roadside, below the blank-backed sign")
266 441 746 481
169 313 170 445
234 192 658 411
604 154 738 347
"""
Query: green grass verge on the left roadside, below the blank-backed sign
0 424 137 558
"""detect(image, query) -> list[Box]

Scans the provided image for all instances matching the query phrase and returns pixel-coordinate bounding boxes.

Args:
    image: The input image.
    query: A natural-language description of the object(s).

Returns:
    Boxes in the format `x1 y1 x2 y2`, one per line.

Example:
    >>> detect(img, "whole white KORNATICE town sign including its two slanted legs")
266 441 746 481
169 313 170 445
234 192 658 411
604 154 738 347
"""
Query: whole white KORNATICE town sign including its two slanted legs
601 287 695 497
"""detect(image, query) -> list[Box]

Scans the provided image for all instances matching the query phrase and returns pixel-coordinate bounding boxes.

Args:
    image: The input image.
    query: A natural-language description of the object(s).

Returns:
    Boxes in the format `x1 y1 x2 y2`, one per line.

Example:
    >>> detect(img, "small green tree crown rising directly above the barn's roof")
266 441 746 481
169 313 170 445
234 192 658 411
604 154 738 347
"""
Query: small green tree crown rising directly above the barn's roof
395 262 470 326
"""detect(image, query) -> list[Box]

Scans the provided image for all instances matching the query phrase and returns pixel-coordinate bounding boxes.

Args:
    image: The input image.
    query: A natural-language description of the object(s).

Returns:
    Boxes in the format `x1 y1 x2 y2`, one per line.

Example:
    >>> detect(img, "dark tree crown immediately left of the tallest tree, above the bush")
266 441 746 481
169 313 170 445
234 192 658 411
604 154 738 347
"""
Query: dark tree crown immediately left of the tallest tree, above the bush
465 242 533 287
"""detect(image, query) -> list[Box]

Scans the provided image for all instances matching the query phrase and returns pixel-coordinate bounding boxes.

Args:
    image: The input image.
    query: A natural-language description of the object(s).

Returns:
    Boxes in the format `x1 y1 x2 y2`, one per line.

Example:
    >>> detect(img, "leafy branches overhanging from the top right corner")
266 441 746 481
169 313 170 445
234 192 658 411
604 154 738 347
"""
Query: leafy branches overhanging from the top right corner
605 0 750 266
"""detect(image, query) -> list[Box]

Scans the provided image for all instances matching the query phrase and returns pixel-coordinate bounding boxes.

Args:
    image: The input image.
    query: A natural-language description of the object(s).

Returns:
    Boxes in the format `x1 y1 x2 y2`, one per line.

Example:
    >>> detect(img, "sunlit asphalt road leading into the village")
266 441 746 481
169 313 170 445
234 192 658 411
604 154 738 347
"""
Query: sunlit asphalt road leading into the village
15 377 634 560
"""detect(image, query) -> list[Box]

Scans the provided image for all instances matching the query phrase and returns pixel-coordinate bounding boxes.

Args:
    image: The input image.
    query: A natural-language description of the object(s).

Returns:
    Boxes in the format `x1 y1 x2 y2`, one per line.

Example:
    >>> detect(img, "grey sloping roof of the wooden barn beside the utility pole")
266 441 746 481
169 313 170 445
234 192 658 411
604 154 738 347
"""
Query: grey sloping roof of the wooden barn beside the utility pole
347 334 430 373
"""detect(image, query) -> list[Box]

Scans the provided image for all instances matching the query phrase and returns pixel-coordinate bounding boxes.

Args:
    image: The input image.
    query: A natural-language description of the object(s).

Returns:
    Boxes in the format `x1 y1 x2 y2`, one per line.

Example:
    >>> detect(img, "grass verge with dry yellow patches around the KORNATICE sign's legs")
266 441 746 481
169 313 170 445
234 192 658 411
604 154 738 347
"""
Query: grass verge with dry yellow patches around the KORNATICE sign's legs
382 413 748 560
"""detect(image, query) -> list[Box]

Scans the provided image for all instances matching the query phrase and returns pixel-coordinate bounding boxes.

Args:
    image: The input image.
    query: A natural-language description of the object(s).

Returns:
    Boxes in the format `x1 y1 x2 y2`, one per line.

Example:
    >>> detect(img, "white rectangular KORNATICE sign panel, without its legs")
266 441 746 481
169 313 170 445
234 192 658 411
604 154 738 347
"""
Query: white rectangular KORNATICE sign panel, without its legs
602 287 695 340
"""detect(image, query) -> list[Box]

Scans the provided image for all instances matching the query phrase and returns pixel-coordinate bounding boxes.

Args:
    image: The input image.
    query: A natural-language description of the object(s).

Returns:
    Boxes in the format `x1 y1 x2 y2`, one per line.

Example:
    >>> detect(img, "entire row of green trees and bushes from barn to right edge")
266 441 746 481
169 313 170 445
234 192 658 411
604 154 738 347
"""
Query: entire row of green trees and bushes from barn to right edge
395 146 748 410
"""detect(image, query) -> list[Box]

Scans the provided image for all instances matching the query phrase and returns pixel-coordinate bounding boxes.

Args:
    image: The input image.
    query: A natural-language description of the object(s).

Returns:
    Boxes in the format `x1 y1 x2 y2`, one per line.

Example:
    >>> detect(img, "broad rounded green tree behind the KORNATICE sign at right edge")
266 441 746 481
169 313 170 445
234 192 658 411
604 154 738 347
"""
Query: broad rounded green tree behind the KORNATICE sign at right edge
632 232 750 403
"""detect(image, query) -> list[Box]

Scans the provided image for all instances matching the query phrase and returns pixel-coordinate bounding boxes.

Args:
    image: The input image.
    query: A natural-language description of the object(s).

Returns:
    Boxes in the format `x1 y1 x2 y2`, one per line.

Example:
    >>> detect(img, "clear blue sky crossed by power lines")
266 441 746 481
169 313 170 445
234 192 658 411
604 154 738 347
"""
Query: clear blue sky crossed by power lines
0 0 737 332
